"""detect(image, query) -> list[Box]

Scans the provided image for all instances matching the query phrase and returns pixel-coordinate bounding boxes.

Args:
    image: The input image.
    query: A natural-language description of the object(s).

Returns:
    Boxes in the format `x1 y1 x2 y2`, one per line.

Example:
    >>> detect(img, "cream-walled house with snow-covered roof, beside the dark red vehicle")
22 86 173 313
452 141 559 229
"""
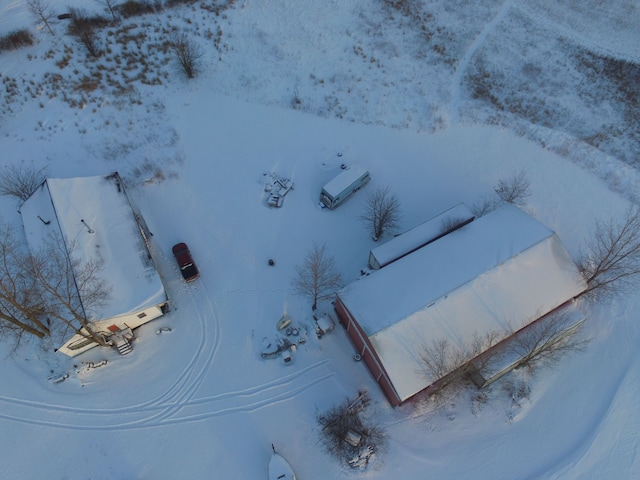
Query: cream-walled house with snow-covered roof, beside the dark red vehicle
20 172 168 357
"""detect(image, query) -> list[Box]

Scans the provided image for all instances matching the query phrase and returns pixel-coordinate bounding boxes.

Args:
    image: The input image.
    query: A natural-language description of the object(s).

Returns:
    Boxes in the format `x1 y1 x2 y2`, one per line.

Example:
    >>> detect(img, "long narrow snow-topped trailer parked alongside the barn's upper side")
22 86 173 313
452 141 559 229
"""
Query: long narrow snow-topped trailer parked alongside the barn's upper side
369 203 475 270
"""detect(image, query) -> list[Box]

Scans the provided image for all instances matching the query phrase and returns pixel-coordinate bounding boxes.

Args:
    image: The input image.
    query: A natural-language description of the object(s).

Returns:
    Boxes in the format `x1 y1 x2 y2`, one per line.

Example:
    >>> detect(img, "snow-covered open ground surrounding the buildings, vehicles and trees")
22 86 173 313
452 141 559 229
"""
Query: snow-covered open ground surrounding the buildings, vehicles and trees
0 0 640 480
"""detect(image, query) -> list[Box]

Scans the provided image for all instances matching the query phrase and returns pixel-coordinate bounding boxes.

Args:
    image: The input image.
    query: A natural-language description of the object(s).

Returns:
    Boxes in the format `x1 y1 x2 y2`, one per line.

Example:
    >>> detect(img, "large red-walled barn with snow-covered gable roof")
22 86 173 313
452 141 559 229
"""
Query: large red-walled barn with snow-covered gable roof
335 205 585 405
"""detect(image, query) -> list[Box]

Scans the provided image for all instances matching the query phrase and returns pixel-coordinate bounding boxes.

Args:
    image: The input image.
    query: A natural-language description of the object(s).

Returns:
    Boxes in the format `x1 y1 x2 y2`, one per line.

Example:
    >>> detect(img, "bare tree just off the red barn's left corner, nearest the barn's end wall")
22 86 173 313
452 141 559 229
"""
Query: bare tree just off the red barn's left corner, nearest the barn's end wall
293 243 342 310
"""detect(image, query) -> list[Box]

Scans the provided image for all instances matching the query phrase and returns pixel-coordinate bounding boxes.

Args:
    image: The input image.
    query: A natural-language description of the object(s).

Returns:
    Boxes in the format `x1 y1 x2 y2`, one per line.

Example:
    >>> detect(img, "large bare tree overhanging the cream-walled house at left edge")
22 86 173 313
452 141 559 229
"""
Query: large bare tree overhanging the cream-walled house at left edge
0 225 110 345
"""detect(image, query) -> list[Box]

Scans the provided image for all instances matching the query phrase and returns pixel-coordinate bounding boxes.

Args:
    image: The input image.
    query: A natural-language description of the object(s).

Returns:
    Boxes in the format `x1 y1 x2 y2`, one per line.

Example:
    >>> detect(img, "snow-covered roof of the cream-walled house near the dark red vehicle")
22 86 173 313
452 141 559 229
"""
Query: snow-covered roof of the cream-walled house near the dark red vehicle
20 174 166 320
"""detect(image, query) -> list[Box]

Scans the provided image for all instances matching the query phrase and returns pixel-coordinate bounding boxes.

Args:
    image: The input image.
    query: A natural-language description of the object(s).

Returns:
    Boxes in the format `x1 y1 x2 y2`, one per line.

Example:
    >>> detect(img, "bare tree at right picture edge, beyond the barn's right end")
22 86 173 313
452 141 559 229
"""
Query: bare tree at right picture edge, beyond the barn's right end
578 208 640 299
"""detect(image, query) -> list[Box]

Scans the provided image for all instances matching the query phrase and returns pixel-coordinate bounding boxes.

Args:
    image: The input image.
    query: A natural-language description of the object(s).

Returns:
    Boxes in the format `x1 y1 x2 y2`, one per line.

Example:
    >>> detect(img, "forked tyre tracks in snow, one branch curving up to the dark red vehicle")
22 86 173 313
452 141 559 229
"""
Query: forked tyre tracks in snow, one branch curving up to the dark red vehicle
0 281 335 430
